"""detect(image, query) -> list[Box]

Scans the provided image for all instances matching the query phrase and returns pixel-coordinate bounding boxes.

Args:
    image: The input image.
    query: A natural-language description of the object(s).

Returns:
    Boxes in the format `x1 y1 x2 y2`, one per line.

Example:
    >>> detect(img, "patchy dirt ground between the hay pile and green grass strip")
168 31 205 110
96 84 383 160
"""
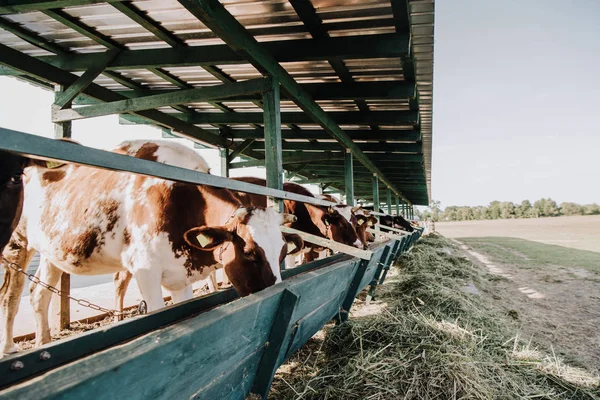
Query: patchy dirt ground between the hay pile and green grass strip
458 238 600 374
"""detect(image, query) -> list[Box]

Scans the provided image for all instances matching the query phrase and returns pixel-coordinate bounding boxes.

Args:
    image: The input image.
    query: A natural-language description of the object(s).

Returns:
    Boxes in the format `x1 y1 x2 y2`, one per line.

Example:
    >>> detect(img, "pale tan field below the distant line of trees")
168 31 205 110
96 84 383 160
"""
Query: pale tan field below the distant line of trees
435 215 600 253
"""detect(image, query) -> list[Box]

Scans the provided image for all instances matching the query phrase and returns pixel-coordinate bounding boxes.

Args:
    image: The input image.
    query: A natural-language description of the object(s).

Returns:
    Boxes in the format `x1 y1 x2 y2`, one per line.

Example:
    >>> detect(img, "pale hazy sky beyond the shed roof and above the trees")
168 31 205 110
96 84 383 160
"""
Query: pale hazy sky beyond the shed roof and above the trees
0 0 600 207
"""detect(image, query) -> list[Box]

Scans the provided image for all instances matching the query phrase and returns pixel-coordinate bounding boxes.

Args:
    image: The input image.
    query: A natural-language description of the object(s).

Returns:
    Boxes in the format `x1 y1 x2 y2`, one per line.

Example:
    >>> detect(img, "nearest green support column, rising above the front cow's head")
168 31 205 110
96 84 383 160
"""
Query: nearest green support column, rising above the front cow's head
263 79 283 212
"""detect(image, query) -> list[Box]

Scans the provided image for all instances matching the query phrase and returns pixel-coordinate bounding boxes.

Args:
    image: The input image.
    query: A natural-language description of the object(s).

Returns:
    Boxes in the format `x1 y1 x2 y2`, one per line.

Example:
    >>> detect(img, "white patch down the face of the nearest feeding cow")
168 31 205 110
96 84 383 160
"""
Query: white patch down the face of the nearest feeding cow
246 208 285 283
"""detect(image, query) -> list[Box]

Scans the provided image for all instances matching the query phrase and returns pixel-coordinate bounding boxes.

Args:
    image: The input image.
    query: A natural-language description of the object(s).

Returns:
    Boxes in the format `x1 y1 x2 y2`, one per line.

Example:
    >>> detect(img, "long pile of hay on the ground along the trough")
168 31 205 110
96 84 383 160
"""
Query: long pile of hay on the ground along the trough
269 235 600 399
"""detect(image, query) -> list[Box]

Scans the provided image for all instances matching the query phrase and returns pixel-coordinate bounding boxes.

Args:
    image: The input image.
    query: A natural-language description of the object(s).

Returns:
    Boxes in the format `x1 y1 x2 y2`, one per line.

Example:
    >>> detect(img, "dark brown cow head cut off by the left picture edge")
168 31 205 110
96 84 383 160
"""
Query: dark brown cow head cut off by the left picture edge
0 151 28 252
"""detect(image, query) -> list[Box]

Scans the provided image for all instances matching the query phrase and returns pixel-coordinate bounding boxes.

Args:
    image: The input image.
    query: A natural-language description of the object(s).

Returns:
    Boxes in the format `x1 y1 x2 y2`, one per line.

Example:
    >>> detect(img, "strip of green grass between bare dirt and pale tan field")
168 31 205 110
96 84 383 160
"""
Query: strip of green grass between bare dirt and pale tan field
457 237 600 273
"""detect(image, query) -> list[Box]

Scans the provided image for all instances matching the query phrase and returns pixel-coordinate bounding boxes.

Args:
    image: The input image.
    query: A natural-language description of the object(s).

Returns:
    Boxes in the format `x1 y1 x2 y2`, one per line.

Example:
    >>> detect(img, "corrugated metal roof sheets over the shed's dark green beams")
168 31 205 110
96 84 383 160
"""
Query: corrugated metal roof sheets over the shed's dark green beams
0 0 434 204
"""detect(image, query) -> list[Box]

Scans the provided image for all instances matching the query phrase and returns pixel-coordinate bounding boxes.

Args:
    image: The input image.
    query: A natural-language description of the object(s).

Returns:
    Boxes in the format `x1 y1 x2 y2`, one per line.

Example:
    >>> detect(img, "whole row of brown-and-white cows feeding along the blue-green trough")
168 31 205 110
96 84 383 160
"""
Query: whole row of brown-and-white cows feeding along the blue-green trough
0 140 413 357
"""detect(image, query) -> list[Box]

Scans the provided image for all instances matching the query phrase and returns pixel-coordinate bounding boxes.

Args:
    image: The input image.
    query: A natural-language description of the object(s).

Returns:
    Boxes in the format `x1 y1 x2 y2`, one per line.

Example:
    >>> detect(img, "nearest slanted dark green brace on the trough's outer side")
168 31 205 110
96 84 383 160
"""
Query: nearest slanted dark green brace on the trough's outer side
252 289 300 400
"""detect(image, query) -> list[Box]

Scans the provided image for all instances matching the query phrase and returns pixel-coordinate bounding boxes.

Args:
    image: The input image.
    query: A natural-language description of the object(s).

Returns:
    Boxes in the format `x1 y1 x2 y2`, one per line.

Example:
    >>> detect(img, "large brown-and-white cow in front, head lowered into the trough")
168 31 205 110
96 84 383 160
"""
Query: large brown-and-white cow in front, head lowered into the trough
0 140 295 353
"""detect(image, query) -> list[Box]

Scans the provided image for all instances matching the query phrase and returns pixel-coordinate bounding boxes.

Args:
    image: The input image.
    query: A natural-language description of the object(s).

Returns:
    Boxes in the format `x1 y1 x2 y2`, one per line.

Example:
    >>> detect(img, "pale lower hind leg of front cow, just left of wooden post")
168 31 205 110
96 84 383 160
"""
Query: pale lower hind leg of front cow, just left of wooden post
29 257 63 346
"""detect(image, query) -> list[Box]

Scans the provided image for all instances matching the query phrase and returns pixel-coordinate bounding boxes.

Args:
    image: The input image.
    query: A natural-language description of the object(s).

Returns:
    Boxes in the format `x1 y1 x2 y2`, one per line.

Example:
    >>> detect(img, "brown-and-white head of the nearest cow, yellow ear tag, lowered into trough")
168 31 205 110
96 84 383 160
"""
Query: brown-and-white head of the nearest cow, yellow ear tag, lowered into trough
184 207 301 296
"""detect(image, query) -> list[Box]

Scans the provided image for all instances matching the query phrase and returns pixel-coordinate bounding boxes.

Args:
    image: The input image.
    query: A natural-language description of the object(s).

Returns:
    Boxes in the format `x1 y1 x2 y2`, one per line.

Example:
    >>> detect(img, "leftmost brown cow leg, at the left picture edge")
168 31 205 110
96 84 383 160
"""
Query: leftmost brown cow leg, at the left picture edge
0 244 35 358
